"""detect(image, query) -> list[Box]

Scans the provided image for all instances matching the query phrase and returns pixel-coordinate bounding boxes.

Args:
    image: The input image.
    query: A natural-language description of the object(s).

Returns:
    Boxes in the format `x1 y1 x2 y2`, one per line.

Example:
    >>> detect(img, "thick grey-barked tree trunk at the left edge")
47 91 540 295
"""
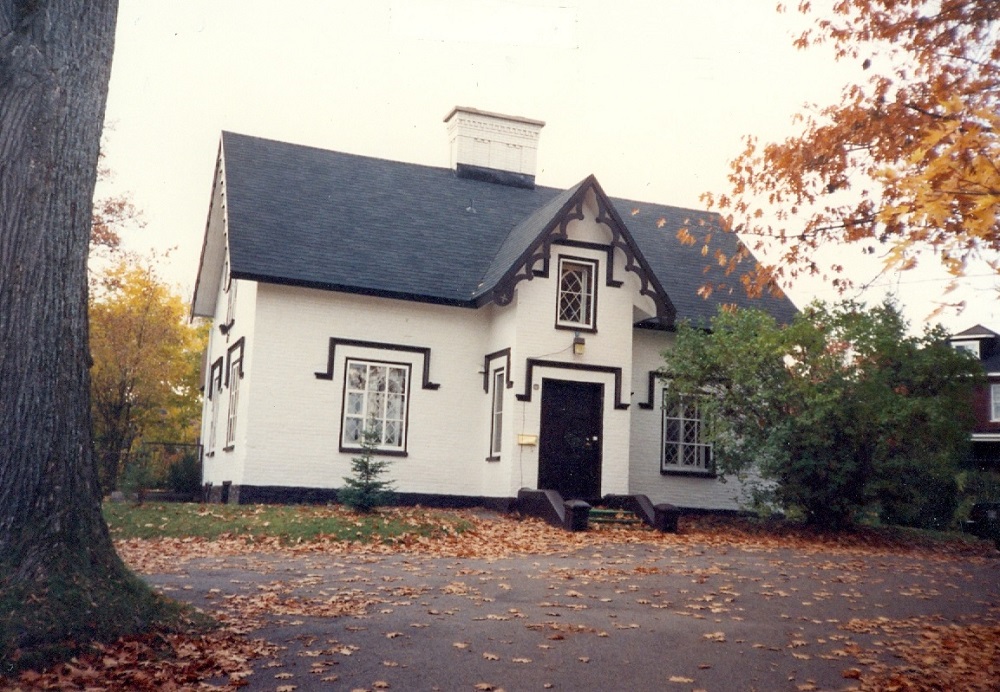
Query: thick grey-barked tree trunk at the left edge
0 0 178 661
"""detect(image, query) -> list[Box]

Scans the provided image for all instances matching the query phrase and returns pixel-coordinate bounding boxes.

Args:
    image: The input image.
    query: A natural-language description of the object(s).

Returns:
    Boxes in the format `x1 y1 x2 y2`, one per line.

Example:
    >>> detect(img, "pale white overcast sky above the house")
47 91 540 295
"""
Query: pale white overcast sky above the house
99 0 1000 330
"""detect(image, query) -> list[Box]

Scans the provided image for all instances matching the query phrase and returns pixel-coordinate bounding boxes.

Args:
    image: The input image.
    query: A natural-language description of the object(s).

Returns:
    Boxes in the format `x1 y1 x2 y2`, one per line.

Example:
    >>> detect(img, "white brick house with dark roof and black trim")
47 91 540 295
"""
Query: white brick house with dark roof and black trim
192 108 795 509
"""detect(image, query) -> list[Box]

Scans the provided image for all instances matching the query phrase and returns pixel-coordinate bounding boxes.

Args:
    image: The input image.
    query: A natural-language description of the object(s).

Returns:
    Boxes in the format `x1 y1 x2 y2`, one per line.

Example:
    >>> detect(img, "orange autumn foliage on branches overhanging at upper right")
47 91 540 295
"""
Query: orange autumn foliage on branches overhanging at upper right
705 0 1000 302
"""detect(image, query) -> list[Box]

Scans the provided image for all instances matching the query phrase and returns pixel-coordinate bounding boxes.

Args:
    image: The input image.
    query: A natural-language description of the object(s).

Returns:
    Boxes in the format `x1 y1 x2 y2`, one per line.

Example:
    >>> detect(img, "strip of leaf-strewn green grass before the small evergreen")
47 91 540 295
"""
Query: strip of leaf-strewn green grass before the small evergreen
104 503 472 544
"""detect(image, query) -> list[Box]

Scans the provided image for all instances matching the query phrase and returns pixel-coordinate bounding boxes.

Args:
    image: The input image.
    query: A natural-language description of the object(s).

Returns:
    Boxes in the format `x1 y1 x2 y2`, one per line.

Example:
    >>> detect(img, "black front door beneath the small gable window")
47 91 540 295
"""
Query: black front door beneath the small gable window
538 379 604 501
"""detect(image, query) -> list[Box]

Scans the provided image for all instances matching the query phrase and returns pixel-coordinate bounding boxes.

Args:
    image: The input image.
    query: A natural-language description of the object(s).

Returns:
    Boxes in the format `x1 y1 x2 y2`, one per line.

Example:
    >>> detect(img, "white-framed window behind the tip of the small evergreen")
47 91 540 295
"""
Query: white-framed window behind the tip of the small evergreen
341 359 410 452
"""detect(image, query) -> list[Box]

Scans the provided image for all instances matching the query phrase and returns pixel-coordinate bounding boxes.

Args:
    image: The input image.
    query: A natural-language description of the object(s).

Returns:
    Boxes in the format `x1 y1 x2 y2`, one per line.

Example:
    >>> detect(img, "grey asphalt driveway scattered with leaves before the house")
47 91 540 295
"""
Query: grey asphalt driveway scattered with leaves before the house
147 537 1000 692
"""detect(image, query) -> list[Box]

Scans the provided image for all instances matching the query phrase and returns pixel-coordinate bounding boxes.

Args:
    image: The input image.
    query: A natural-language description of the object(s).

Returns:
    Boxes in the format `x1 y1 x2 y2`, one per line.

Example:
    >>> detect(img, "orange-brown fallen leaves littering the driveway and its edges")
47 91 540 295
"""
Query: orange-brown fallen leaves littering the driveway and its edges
0 508 1000 690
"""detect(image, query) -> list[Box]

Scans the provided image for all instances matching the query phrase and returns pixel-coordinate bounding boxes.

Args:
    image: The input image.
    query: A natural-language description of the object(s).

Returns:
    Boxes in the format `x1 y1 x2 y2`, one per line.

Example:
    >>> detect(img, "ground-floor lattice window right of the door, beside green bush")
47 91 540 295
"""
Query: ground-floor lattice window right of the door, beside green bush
660 390 713 473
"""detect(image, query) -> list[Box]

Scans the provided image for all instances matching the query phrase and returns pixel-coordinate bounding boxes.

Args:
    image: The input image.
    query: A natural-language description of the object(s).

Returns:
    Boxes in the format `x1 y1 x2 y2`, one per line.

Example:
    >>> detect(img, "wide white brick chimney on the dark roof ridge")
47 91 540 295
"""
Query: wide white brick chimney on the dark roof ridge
444 106 545 188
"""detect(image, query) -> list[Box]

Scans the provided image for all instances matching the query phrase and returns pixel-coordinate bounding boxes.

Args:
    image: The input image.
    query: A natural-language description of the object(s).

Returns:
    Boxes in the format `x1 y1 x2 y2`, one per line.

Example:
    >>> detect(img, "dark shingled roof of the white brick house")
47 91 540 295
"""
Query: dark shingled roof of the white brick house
195 132 796 322
